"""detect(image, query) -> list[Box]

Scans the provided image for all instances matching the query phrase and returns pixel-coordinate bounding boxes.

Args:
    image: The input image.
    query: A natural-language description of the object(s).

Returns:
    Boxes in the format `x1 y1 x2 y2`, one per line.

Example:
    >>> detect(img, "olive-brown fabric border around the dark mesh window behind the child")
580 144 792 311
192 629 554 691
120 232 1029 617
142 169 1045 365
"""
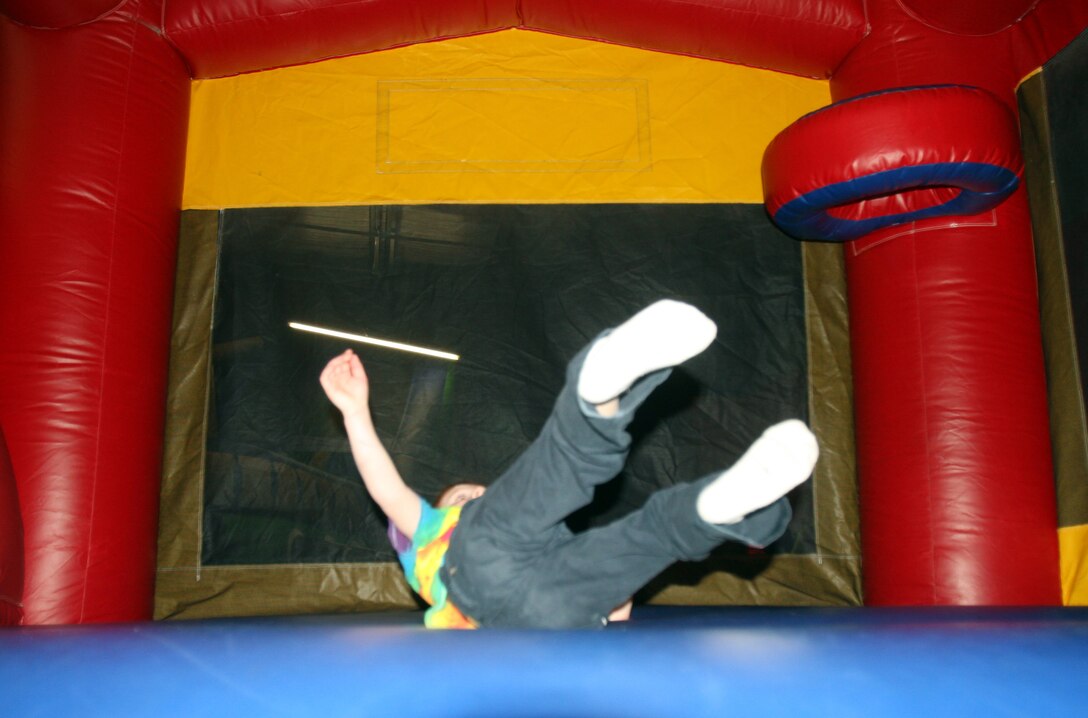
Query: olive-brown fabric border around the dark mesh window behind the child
154 210 862 619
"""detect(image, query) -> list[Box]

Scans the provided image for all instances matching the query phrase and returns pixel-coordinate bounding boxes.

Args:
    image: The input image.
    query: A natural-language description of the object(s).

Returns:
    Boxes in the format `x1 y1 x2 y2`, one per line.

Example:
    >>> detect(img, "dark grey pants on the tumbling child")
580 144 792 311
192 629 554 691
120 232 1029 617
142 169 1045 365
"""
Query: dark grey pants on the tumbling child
442 332 792 628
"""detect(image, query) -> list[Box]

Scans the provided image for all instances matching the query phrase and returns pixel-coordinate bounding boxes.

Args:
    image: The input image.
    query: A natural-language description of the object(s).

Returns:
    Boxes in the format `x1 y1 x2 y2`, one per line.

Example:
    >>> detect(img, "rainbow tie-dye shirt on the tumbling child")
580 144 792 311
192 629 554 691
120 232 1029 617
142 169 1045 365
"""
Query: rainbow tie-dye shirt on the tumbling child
390 499 475 629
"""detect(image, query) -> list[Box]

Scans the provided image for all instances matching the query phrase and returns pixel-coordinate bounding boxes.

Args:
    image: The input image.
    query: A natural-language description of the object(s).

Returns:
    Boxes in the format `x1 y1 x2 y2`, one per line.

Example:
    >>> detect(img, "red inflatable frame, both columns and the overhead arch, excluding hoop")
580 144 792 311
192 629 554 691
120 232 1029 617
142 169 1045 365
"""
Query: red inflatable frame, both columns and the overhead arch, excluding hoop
0 0 1088 623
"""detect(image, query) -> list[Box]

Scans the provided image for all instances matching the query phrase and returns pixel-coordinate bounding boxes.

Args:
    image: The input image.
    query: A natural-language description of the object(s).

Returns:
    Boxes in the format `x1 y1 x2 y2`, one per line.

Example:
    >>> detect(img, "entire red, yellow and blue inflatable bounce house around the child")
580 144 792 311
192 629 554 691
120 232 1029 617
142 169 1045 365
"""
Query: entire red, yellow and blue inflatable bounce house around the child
0 0 1088 716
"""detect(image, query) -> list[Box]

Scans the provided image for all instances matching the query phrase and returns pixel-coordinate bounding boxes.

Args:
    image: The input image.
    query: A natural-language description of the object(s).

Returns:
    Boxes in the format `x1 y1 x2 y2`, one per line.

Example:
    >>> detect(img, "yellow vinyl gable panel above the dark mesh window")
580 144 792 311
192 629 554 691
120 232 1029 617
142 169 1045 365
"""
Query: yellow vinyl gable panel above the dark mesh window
183 30 830 209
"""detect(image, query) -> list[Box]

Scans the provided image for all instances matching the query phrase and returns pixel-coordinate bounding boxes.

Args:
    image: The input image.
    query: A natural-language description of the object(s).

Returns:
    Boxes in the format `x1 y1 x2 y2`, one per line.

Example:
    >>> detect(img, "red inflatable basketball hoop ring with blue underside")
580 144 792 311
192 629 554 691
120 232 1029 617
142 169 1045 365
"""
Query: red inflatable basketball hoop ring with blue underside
763 85 1023 242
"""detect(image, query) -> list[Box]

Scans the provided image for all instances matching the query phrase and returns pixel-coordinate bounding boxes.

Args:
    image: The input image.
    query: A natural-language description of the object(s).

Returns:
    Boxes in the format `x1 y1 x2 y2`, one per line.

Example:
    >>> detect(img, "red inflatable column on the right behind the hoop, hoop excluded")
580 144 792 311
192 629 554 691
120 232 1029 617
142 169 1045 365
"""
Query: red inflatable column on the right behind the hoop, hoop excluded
831 0 1061 605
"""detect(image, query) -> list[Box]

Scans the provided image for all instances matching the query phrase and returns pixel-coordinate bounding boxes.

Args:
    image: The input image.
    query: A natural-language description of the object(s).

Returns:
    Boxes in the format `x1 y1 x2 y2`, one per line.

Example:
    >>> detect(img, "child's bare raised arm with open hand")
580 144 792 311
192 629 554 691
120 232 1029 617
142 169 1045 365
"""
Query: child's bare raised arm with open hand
321 349 421 539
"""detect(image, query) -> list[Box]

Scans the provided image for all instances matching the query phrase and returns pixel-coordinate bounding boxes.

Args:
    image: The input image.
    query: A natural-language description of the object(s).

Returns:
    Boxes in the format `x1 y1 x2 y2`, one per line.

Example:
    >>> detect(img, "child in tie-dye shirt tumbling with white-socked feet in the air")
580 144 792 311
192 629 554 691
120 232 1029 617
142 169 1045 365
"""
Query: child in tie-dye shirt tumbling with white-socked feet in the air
321 299 819 628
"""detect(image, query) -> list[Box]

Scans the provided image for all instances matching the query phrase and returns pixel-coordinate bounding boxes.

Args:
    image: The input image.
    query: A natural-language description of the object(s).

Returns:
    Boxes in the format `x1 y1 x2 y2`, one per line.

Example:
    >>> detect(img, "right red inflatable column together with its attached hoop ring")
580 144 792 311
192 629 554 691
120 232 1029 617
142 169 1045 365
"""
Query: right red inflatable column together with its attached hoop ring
764 86 1060 605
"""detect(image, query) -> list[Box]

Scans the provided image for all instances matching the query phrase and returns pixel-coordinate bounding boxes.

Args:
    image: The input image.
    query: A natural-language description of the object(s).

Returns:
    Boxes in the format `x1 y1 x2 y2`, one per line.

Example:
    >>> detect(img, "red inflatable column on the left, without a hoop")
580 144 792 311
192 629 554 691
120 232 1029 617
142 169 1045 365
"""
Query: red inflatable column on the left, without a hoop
0 0 189 623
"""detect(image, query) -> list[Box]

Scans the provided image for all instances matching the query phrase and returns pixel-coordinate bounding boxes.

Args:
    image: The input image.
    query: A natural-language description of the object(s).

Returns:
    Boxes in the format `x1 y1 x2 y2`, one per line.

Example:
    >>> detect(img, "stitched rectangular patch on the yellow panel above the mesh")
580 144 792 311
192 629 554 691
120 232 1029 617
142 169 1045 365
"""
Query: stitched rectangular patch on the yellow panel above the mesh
375 78 651 173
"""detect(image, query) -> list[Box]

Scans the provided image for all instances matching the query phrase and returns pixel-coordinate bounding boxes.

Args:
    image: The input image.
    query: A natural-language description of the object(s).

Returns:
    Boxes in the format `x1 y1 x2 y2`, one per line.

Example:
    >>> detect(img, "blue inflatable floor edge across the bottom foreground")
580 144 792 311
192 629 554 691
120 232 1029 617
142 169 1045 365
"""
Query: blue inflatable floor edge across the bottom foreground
0 607 1088 718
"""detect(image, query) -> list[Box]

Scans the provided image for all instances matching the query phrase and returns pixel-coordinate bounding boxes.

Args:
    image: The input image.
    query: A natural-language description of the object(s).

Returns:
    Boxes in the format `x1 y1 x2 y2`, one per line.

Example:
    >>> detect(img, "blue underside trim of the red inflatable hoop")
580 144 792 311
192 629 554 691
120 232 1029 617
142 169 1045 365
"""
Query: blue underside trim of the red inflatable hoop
774 162 1019 242
